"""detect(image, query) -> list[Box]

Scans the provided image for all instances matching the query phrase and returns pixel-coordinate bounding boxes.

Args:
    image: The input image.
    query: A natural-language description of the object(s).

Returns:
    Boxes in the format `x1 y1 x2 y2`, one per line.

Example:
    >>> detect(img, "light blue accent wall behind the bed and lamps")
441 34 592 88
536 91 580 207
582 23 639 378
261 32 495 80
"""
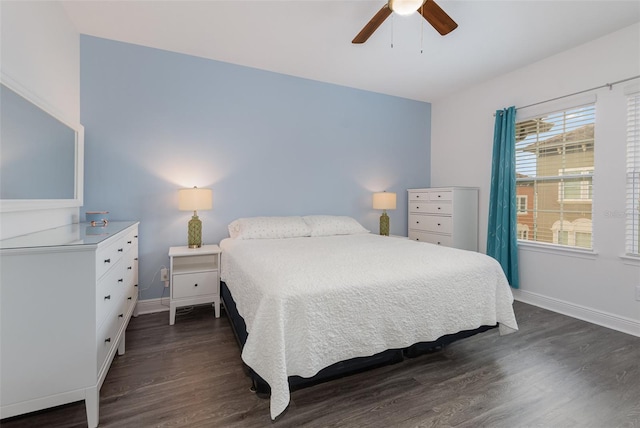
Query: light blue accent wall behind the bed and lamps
80 36 431 299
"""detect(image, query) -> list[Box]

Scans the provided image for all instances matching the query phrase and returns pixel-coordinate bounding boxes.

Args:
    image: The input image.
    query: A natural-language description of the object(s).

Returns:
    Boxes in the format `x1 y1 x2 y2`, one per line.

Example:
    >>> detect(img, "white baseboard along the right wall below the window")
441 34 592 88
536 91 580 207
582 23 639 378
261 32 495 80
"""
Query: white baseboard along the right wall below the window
512 290 640 337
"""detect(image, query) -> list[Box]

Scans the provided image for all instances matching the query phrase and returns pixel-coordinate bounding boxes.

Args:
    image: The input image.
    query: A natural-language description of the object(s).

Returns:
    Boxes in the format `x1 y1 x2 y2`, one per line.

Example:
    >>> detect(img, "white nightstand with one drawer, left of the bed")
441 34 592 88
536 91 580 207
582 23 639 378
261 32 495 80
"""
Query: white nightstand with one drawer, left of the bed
169 245 221 325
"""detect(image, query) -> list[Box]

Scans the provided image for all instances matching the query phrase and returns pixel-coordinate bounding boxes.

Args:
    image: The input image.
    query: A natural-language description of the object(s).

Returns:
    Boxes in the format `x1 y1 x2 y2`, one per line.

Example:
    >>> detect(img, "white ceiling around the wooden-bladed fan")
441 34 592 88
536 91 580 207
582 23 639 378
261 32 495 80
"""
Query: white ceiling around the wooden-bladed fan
63 0 640 101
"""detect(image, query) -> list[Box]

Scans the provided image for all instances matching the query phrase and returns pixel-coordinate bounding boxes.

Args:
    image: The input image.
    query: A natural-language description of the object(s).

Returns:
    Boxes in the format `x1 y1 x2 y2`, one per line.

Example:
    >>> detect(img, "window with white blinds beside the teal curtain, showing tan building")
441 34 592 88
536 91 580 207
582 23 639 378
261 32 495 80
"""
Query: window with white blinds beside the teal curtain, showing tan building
516 104 595 249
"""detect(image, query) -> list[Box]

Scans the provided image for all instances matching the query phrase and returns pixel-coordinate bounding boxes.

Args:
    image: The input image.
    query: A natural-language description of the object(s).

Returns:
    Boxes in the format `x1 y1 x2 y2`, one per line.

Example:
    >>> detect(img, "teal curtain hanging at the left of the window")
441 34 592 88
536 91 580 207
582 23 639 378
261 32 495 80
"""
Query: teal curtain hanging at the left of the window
487 107 520 288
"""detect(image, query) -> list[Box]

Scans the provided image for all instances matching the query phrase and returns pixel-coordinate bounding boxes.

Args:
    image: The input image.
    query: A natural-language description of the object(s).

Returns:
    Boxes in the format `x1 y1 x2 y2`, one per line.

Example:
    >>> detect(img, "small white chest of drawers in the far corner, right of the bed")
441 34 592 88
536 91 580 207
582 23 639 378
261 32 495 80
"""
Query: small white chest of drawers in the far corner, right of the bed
408 187 478 251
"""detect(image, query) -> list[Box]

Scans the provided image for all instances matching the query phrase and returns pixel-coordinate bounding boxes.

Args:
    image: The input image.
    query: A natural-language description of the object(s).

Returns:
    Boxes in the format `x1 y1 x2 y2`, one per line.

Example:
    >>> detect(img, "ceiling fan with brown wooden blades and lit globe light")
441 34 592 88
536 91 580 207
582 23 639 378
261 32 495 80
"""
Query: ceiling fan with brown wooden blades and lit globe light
351 0 458 44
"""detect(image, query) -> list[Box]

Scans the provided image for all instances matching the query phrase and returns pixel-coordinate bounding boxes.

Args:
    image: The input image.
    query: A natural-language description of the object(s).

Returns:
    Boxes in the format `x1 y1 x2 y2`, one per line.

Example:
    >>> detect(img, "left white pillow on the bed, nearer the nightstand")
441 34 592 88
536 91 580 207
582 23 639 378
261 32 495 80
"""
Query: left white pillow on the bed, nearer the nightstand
228 216 311 239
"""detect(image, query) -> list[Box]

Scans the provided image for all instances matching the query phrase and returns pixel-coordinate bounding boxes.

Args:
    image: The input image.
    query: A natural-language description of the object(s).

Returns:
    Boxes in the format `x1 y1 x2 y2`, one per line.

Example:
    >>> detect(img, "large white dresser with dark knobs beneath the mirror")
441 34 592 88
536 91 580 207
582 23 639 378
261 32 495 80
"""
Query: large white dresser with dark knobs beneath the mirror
0 222 138 427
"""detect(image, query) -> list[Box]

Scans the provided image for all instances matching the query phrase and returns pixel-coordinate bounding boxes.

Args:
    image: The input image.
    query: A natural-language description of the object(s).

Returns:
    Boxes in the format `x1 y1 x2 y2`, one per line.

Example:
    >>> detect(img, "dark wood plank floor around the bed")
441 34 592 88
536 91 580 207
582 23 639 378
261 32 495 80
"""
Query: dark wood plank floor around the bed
1 302 640 428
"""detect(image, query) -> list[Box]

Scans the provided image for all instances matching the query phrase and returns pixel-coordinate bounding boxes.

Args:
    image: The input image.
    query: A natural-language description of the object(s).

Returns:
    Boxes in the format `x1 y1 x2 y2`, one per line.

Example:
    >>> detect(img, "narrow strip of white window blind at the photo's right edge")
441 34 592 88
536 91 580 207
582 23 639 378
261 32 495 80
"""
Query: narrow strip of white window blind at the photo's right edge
626 93 640 256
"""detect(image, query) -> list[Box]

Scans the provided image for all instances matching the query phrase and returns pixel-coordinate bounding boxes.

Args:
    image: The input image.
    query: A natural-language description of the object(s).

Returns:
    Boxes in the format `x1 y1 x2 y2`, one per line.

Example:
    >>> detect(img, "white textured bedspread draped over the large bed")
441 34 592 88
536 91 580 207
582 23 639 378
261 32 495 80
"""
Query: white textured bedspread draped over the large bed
221 234 518 419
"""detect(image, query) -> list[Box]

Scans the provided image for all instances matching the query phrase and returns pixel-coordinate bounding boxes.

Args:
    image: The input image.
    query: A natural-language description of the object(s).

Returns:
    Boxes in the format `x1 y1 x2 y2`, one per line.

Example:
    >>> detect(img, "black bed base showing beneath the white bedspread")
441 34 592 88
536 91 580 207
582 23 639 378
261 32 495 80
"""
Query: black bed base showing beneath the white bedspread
220 282 497 398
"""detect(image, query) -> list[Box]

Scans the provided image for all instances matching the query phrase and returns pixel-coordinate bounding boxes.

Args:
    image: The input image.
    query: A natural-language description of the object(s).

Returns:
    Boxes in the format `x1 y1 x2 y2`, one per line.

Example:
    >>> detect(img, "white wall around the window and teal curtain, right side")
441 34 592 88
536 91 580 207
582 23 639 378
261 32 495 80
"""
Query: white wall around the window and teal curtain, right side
431 23 640 336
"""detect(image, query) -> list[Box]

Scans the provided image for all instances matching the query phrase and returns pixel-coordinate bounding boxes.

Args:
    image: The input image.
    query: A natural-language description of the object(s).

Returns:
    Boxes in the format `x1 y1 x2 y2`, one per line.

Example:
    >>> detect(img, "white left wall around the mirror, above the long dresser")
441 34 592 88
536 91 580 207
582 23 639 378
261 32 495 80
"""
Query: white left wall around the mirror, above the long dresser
0 0 80 239
